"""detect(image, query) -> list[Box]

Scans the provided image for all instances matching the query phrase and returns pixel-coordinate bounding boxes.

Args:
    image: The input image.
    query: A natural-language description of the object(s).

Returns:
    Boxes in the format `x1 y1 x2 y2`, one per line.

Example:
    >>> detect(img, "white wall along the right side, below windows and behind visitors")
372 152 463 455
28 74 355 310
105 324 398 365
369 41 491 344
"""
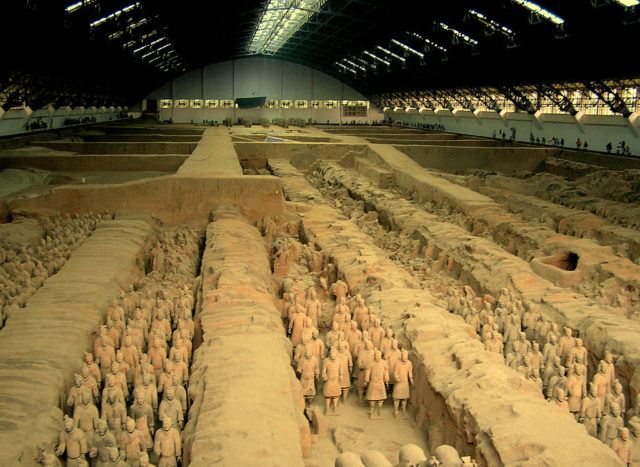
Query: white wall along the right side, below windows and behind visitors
385 109 640 156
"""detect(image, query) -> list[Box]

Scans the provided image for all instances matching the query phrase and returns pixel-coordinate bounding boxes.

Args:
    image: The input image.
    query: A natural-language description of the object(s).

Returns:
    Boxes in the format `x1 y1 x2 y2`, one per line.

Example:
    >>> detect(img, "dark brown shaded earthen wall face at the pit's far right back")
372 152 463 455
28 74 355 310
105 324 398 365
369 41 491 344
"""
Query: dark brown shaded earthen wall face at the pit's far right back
394 145 557 172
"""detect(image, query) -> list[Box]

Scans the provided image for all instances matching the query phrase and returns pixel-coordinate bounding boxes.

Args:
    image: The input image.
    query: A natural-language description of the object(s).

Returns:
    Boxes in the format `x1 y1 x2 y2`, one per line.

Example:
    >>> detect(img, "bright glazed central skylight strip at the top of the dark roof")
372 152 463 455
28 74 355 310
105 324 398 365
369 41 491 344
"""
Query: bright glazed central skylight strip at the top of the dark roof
248 0 327 54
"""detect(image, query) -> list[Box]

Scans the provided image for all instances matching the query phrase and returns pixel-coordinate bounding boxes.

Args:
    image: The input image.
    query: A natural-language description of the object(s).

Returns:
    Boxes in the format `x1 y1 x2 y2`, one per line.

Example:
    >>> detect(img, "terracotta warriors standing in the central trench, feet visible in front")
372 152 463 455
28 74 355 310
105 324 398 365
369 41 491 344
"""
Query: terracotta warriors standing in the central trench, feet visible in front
283 280 413 417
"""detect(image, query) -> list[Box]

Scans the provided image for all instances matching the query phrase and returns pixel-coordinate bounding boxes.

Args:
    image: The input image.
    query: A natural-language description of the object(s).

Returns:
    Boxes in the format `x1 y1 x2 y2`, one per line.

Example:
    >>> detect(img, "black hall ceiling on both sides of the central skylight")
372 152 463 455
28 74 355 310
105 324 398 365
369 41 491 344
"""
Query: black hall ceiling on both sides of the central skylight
0 0 640 107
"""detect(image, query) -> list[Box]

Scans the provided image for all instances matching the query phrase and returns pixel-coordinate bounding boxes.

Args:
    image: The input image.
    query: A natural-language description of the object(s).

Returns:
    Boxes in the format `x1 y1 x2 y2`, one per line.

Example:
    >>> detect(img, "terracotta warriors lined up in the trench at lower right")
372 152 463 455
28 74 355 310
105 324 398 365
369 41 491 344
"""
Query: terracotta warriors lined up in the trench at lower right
448 286 640 462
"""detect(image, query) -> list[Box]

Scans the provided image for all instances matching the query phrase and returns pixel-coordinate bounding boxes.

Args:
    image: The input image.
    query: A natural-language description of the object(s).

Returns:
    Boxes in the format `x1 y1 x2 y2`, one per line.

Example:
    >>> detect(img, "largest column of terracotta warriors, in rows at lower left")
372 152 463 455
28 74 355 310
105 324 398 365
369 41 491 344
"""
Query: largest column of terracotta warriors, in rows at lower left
56 227 199 467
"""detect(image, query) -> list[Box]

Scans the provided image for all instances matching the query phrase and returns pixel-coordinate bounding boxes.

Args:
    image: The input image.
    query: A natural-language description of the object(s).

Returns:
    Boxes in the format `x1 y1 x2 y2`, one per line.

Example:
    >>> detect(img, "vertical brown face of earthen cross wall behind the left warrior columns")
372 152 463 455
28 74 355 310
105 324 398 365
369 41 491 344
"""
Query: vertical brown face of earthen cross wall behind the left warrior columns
9 176 283 225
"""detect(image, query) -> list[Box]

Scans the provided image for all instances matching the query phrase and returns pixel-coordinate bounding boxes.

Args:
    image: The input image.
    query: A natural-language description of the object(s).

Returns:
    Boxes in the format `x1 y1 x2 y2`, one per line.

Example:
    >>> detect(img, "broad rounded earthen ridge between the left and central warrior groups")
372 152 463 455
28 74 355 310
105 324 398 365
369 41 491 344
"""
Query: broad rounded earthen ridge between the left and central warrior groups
183 209 311 467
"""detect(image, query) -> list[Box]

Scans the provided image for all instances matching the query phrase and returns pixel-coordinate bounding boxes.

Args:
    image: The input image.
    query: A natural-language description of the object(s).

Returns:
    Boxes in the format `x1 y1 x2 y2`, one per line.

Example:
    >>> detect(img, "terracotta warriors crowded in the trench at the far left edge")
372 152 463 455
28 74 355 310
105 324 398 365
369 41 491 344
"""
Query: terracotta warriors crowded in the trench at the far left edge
0 214 103 329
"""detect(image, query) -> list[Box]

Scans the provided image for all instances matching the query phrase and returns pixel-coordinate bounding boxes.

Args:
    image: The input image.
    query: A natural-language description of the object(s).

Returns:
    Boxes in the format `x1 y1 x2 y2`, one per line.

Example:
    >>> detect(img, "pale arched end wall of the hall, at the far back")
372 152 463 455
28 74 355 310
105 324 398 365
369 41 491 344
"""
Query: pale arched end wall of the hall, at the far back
146 57 384 124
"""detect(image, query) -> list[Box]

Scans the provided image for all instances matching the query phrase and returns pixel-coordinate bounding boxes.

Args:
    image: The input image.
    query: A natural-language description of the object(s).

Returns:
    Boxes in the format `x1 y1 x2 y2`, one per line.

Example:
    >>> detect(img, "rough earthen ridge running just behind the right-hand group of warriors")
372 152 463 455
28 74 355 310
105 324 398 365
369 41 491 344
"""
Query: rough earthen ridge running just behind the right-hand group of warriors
310 158 640 406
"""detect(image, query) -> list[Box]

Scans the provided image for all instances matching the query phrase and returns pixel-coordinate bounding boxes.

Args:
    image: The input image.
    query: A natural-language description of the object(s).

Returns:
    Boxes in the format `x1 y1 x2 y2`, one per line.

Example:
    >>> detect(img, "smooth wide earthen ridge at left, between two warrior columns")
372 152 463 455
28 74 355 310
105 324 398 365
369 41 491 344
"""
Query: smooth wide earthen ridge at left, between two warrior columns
0 220 151 466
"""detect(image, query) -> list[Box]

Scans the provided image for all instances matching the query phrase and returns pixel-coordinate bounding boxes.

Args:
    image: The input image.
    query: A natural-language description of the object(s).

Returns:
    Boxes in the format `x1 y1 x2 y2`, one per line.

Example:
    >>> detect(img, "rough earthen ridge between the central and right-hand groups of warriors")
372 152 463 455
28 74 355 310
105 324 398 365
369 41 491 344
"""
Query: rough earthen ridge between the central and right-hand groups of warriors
269 159 619 465
